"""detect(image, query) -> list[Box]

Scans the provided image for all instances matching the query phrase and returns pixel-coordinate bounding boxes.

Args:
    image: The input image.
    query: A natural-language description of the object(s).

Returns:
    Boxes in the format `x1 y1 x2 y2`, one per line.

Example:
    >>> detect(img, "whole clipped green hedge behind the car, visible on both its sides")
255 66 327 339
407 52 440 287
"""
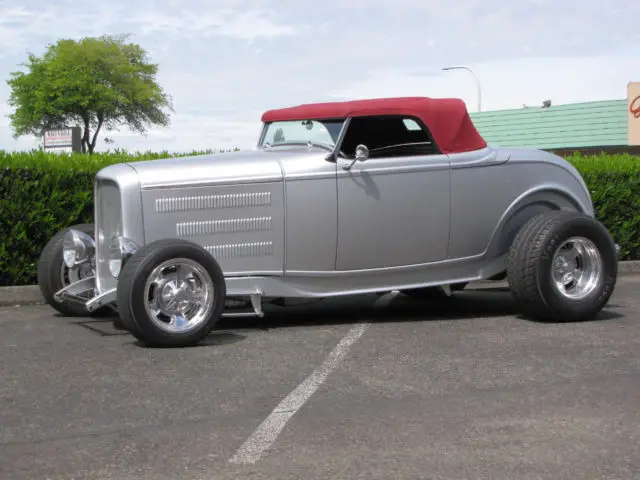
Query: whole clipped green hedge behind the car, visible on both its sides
0 151 640 286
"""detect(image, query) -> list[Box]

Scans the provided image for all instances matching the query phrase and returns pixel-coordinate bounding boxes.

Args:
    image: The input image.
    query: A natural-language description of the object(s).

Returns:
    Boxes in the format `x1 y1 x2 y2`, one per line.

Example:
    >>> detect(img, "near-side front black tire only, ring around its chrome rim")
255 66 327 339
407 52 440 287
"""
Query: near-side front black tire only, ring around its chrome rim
116 239 226 347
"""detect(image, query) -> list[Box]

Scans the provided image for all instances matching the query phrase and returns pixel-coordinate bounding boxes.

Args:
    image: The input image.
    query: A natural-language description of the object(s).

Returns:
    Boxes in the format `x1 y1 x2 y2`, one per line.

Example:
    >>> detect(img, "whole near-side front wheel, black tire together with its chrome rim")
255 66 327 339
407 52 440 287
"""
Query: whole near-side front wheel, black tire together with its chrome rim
117 239 226 347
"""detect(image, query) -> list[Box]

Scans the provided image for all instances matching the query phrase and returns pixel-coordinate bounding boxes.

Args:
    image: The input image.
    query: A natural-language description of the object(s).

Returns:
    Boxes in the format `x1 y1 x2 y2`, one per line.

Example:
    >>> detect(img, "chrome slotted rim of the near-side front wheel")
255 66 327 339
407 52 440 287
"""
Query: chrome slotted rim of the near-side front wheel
144 258 215 333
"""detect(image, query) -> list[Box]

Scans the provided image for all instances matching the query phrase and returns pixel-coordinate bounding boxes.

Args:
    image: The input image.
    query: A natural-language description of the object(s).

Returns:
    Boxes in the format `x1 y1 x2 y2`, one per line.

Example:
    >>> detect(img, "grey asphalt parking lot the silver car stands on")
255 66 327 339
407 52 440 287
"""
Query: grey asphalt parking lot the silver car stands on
0 276 640 480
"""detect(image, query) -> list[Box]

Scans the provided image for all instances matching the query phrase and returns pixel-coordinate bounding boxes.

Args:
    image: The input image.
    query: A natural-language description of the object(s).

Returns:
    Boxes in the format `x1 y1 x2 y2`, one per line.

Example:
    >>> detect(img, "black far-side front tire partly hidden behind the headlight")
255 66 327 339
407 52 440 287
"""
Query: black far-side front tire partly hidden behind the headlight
38 223 111 317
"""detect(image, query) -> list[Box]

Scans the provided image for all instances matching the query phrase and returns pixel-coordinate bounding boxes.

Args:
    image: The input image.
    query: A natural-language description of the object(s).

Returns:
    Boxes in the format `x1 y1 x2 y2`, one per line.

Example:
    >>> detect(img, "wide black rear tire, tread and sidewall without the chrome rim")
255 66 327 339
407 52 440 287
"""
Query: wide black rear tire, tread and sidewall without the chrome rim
507 211 618 322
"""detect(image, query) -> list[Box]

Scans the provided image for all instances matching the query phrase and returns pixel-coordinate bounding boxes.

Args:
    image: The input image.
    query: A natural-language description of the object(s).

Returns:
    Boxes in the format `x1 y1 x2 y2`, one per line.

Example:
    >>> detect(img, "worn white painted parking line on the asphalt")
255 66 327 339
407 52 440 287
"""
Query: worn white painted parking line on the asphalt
229 323 369 463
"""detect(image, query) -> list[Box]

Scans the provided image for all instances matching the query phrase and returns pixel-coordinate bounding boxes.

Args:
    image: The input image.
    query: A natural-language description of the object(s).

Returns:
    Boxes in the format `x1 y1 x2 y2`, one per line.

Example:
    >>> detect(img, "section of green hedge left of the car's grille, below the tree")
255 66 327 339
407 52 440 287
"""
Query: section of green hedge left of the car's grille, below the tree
0 150 235 286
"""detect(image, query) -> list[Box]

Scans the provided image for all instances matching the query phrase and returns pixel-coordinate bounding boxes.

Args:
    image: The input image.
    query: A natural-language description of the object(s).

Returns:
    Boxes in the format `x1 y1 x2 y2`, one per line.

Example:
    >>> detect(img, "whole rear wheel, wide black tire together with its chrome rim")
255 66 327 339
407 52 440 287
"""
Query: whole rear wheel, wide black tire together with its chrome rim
507 211 618 322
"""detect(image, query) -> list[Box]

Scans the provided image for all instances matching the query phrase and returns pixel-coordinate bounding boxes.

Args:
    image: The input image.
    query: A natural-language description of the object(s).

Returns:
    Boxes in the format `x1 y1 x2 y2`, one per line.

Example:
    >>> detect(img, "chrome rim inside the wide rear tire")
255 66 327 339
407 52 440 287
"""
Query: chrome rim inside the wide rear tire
552 237 602 300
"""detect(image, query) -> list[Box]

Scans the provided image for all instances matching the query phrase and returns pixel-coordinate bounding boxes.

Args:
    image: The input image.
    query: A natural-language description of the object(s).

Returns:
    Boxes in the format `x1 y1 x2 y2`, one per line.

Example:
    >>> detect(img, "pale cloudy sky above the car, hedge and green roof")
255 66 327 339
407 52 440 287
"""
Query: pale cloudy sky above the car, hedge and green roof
0 0 640 151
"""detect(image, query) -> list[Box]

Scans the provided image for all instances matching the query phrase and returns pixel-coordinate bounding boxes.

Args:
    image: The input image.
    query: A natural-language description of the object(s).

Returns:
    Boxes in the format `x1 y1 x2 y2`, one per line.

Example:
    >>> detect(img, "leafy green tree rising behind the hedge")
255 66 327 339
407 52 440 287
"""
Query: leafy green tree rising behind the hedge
7 36 173 154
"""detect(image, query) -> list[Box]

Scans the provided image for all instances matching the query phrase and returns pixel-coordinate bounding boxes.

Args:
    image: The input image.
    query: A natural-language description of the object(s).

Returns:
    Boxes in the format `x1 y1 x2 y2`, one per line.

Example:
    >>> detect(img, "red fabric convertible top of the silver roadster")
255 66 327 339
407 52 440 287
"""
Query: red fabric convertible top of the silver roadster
262 97 487 153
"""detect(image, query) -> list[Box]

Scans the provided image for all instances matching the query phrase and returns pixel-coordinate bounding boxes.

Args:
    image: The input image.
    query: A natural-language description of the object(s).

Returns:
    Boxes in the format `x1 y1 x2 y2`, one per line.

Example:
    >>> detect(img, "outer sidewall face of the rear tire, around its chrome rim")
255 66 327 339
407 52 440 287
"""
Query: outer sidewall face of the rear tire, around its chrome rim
537 216 618 321
